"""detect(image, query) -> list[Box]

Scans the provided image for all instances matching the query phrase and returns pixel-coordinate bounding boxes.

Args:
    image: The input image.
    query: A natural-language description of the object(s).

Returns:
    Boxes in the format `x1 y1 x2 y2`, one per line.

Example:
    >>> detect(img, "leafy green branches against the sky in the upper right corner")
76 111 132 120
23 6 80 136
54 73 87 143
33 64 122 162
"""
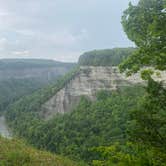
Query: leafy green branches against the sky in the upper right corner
120 0 166 72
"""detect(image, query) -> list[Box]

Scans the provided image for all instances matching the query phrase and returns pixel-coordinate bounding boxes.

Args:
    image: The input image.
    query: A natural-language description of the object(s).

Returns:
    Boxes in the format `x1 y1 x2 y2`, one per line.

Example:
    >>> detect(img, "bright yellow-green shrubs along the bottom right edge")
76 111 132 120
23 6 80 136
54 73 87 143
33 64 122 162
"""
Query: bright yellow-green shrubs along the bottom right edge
92 142 166 166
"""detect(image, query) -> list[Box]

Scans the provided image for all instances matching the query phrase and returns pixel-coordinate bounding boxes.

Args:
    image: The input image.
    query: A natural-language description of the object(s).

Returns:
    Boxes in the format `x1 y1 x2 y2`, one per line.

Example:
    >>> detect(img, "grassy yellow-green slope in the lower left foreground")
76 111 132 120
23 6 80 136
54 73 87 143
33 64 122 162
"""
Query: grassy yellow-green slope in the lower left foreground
0 137 85 166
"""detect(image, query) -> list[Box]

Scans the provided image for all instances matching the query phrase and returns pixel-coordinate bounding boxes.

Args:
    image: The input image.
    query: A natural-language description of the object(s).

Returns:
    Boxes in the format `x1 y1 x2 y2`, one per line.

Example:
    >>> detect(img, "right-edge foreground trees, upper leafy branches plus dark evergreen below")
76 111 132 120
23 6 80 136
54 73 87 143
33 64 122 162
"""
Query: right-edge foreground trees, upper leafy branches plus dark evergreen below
120 0 166 160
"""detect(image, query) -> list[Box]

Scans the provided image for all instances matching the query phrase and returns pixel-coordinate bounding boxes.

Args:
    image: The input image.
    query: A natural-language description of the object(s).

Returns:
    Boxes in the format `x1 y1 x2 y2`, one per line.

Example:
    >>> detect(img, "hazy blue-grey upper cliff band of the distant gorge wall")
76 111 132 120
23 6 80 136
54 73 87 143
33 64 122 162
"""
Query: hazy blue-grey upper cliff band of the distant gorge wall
0 59 75 83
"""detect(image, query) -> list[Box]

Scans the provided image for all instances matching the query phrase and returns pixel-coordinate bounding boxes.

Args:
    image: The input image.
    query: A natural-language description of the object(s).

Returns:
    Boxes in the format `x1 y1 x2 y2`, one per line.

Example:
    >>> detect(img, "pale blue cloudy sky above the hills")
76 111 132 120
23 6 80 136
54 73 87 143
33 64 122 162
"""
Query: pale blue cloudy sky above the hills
0 0 138 62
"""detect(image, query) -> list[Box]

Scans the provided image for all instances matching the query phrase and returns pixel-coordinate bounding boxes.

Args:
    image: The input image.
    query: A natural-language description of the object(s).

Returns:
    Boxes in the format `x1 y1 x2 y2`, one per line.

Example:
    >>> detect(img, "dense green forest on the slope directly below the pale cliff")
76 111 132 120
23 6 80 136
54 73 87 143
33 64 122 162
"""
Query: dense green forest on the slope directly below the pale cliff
8 87 143 161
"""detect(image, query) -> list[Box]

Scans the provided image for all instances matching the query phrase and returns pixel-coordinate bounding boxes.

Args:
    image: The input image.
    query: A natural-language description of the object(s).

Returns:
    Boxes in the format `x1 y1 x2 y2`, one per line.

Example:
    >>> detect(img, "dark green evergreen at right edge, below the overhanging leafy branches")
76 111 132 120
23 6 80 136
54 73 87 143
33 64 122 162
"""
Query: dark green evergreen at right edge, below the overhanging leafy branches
129 79 166 148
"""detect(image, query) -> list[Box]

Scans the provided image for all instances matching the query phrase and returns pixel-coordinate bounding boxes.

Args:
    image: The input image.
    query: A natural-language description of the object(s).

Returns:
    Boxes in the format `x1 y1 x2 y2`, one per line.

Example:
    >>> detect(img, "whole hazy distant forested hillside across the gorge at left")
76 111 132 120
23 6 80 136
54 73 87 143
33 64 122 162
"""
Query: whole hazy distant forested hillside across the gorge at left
0 59 75 112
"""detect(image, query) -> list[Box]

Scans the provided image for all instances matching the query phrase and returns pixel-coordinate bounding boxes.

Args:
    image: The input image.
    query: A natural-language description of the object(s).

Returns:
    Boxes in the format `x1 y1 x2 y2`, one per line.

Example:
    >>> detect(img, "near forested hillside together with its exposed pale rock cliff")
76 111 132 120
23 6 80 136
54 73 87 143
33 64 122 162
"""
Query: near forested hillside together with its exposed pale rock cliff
6 62 166 164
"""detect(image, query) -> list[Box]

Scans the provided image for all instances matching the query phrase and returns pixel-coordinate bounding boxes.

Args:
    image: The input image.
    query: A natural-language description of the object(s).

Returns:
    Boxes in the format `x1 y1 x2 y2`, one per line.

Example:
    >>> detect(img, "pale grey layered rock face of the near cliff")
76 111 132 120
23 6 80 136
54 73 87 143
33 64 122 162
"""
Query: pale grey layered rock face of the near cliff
41 66 166 119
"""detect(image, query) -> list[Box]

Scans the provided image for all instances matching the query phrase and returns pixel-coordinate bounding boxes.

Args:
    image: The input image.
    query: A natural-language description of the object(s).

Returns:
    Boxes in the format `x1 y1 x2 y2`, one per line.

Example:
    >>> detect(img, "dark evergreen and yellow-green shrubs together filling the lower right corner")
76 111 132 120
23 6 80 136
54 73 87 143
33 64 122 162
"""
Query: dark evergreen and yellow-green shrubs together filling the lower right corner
92 78 166 166
